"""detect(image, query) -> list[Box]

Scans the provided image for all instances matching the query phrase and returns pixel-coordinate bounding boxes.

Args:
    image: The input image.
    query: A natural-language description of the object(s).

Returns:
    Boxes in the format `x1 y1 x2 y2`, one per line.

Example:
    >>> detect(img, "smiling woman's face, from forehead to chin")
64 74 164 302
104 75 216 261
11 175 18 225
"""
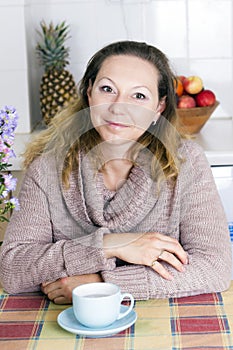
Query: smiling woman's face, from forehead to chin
88 55 165 142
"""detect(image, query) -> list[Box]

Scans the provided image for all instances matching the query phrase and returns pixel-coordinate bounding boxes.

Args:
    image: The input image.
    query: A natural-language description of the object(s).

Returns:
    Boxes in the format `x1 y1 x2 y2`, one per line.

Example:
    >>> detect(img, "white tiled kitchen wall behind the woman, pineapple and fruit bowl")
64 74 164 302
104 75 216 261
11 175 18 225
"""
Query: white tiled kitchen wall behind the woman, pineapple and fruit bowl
0 0 233 133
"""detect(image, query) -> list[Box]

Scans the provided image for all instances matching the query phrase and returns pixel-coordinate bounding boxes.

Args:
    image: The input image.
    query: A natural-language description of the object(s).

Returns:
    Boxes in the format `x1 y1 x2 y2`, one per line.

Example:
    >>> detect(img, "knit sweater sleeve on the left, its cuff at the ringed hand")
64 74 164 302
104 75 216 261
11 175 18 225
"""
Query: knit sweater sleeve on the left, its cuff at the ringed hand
0 159 115 293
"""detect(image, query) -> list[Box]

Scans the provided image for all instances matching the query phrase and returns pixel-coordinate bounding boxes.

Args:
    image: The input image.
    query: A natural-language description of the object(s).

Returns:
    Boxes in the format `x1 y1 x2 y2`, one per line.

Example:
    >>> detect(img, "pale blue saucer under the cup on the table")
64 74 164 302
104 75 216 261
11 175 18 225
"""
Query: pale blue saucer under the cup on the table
57 305 137 338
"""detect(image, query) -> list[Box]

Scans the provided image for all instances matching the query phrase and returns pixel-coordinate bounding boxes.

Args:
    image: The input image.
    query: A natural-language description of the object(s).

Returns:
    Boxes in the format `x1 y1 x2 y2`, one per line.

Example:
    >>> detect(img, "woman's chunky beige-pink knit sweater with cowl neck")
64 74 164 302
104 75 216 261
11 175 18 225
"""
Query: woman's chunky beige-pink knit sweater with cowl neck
0 141 232 299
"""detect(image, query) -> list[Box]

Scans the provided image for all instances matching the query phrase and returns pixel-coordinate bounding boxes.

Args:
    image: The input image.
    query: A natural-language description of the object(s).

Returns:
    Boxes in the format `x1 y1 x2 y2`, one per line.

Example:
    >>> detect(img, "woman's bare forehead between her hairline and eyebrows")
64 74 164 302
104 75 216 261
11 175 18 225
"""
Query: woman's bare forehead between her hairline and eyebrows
97 55 159 83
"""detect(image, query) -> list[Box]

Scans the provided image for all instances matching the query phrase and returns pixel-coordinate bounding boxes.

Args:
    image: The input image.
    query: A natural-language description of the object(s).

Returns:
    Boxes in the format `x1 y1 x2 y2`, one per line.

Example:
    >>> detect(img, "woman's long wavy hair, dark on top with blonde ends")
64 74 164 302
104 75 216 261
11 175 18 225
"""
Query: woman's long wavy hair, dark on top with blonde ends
24 41 182 188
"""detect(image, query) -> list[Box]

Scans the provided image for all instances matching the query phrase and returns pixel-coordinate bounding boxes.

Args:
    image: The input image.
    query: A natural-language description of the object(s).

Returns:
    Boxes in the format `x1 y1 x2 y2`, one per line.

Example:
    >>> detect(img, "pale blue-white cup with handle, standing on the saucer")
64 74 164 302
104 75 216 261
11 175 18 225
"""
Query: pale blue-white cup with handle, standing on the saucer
72 282 134 328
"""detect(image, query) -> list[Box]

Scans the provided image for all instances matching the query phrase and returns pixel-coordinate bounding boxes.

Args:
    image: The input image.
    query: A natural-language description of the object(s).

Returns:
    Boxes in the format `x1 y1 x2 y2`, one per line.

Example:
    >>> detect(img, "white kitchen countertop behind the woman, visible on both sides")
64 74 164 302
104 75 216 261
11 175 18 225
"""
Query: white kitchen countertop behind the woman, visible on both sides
11 118 233 170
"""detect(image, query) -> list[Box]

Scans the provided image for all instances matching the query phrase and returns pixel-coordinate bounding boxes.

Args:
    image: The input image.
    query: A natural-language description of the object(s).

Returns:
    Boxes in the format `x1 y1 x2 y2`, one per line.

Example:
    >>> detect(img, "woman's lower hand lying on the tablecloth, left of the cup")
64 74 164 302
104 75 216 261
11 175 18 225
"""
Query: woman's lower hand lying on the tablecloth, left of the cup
41 273 103 304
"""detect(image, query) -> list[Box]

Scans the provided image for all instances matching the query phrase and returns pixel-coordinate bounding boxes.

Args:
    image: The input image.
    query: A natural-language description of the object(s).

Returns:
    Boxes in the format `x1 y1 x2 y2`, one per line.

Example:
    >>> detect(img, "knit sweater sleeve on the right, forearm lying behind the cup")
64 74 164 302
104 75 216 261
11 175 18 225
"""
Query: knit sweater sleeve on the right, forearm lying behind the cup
102 141 232 299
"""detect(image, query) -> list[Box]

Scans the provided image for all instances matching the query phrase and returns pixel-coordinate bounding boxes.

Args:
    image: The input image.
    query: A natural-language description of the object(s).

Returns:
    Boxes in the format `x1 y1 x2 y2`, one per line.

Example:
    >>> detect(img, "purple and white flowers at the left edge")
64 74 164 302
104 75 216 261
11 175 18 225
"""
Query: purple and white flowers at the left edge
0 106 19 222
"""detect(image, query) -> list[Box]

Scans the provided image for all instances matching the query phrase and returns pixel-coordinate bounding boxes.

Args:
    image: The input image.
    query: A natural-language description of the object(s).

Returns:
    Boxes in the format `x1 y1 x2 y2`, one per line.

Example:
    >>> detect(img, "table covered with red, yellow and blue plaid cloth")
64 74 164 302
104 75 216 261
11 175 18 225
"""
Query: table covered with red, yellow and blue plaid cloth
0 281 233 350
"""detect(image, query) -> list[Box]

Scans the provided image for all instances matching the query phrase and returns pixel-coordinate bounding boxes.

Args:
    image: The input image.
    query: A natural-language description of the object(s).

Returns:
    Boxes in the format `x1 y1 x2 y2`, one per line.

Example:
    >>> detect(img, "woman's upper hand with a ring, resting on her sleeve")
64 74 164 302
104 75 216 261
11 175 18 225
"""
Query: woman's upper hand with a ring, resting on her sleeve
104 232 188 280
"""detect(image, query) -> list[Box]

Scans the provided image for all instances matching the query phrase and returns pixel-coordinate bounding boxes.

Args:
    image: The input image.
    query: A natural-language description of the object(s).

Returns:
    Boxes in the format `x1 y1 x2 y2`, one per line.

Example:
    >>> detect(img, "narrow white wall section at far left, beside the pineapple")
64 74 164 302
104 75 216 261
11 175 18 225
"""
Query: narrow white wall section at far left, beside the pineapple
0 0 31 132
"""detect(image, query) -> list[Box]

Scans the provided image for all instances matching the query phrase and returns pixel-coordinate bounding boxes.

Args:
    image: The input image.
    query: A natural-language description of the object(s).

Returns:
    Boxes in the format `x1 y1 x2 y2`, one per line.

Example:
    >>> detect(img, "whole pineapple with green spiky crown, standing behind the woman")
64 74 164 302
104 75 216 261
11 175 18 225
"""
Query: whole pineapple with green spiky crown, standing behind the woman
36 21 77 124
